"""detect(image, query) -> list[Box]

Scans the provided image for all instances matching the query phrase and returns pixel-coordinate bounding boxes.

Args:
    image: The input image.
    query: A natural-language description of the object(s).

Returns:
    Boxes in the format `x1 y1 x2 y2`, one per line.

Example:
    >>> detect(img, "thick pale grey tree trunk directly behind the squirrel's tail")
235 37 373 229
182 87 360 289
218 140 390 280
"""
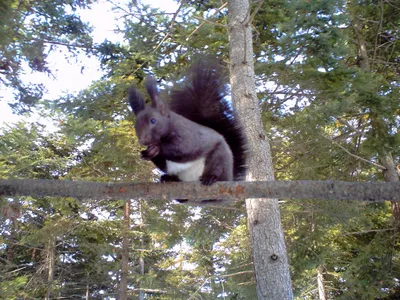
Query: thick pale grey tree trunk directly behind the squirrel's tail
228 0 293 300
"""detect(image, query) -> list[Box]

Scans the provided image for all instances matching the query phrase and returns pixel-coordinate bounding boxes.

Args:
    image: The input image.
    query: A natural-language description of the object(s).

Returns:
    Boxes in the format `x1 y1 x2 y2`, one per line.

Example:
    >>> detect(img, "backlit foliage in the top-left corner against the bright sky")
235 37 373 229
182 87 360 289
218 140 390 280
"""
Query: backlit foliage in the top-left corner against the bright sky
0 0 92 112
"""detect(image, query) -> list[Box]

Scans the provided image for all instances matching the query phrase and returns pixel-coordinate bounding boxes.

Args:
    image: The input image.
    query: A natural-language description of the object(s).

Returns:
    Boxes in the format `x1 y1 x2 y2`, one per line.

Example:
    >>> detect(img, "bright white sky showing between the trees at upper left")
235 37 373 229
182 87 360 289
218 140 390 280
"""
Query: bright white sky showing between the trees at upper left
0 0 177 127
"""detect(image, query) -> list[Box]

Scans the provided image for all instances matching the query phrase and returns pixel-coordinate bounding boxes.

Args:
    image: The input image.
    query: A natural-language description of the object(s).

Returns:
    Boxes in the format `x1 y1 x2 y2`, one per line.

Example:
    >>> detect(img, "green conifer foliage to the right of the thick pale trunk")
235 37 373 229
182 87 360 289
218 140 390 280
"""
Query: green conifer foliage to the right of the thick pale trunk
257 1 400 299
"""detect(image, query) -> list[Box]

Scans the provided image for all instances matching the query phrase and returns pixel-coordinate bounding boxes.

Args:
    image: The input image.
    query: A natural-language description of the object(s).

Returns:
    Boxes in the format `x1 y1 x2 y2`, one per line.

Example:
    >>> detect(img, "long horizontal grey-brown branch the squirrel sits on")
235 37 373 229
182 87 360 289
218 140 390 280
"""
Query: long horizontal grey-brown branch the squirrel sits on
0 179 400 203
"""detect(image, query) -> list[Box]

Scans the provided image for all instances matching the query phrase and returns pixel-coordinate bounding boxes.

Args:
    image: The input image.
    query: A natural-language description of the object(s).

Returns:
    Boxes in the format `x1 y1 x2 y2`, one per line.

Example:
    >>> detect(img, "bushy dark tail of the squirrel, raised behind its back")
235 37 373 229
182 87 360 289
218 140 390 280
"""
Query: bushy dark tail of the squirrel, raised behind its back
169 60 247 181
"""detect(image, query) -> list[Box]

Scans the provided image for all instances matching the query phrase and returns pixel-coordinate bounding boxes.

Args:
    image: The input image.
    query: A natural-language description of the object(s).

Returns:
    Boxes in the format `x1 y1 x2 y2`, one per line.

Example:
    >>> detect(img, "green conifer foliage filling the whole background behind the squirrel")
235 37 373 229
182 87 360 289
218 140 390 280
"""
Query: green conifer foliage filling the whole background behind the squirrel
0 0 400 299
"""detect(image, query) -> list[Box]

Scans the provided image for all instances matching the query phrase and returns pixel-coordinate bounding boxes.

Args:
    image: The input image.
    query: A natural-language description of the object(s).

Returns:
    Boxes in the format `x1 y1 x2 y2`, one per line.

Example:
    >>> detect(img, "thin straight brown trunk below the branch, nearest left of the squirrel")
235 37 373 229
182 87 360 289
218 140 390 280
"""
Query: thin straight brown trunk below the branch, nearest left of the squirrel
119 200 130 300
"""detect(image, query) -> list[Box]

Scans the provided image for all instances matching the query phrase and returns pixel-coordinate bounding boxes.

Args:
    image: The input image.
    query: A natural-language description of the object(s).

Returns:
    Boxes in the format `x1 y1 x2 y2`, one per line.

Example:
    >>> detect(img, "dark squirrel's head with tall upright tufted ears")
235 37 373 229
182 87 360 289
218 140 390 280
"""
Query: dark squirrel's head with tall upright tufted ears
128 78 170 146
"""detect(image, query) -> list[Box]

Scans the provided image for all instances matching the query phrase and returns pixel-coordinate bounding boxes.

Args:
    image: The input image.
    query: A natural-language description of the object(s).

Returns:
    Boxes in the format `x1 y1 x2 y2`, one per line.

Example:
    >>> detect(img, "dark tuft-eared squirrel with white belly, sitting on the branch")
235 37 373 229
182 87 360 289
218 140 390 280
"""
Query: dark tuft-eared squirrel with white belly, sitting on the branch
129 61 247 202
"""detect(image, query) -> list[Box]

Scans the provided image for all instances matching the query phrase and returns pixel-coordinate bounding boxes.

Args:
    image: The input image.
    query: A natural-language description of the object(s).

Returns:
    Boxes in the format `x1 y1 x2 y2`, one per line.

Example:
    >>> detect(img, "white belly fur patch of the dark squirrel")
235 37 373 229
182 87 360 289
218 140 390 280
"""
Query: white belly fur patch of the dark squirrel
167 157 205 181
